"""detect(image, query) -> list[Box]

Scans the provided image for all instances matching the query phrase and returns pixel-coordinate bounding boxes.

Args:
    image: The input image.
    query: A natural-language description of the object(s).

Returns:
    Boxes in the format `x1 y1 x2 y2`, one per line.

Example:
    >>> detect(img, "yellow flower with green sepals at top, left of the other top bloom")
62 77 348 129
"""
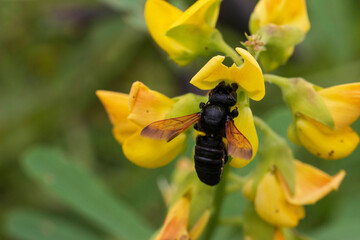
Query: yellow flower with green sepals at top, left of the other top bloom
145 0 222 65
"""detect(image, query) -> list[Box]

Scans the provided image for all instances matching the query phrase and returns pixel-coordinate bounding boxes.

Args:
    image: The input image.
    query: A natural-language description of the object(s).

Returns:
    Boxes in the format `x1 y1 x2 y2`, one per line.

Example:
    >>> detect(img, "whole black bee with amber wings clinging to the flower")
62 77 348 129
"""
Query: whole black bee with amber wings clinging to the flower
141 82 252 186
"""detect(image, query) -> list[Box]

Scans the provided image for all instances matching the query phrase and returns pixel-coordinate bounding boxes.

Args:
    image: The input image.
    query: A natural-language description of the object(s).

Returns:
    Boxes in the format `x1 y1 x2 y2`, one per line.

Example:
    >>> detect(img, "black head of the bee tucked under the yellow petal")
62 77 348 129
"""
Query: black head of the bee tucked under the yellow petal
209 81 238 107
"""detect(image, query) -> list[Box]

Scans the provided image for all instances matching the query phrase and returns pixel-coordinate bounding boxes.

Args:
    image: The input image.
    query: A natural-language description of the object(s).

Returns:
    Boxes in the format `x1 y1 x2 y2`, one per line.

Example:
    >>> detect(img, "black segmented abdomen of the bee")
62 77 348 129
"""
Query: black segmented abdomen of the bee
194 136 225 186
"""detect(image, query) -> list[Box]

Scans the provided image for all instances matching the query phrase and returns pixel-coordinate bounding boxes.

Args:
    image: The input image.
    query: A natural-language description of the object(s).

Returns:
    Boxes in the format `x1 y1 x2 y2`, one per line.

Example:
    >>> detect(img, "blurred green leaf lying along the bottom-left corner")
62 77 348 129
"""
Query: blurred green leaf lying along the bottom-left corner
5 210 103 240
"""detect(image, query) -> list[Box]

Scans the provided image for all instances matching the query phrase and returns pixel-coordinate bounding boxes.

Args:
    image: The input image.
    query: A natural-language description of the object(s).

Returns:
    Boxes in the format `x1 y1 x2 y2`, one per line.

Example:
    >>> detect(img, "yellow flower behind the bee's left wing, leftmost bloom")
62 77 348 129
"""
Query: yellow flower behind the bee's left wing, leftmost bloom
96 82 186 168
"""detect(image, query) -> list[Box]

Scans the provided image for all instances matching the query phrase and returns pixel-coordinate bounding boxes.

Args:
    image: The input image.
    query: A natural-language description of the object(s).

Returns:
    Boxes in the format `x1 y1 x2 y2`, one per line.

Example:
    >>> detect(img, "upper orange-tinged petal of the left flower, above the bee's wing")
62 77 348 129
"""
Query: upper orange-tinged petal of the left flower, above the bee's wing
128 82 174 128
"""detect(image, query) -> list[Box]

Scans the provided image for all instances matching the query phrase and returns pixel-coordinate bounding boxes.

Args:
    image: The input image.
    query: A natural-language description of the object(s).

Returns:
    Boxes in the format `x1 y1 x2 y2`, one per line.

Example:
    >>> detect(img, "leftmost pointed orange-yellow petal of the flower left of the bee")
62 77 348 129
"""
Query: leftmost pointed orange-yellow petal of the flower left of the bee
96 90 139 143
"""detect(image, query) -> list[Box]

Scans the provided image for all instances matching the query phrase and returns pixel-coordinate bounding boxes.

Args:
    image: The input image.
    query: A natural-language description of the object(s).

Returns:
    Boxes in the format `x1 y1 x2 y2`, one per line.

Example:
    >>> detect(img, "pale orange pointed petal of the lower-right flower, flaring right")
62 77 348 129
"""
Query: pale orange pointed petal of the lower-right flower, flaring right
279 160 345 205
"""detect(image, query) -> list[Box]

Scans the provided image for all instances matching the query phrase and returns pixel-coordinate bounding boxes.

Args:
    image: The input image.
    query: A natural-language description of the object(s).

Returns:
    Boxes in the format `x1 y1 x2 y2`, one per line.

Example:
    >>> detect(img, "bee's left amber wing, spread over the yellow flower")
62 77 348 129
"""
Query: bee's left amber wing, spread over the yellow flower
141 113 200 142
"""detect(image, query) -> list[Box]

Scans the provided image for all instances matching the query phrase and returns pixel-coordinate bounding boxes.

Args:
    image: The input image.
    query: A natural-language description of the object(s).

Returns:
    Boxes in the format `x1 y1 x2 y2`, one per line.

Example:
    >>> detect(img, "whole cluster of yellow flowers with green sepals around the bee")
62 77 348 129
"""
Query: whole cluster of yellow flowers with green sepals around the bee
97 0 360 240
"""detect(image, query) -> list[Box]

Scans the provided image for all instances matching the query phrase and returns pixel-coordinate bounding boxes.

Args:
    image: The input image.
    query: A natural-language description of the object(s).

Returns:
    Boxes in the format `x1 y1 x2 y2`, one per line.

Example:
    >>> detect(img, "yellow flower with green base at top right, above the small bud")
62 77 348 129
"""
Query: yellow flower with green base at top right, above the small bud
249 0 310 71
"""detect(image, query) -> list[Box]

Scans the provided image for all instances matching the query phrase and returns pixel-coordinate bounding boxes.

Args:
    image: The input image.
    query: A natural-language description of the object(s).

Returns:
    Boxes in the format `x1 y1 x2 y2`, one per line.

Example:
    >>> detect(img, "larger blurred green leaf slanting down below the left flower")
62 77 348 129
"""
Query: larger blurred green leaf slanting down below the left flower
23 147 152 239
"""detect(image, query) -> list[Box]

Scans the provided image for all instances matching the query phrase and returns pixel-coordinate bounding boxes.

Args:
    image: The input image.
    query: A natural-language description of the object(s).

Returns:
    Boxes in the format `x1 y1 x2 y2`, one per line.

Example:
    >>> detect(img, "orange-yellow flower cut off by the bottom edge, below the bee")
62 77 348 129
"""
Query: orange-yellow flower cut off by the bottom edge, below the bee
154 195 210 240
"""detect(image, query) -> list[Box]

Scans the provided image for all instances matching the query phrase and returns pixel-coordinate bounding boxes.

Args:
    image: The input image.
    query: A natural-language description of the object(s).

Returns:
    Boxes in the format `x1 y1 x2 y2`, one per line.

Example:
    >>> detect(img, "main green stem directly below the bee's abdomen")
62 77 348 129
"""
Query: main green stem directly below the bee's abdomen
202 165 230 240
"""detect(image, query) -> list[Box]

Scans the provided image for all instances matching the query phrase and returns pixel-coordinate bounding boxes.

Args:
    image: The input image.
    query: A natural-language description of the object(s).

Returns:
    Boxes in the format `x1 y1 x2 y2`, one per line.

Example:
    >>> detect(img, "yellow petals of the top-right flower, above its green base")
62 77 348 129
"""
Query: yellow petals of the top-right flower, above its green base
251 0 310 33
